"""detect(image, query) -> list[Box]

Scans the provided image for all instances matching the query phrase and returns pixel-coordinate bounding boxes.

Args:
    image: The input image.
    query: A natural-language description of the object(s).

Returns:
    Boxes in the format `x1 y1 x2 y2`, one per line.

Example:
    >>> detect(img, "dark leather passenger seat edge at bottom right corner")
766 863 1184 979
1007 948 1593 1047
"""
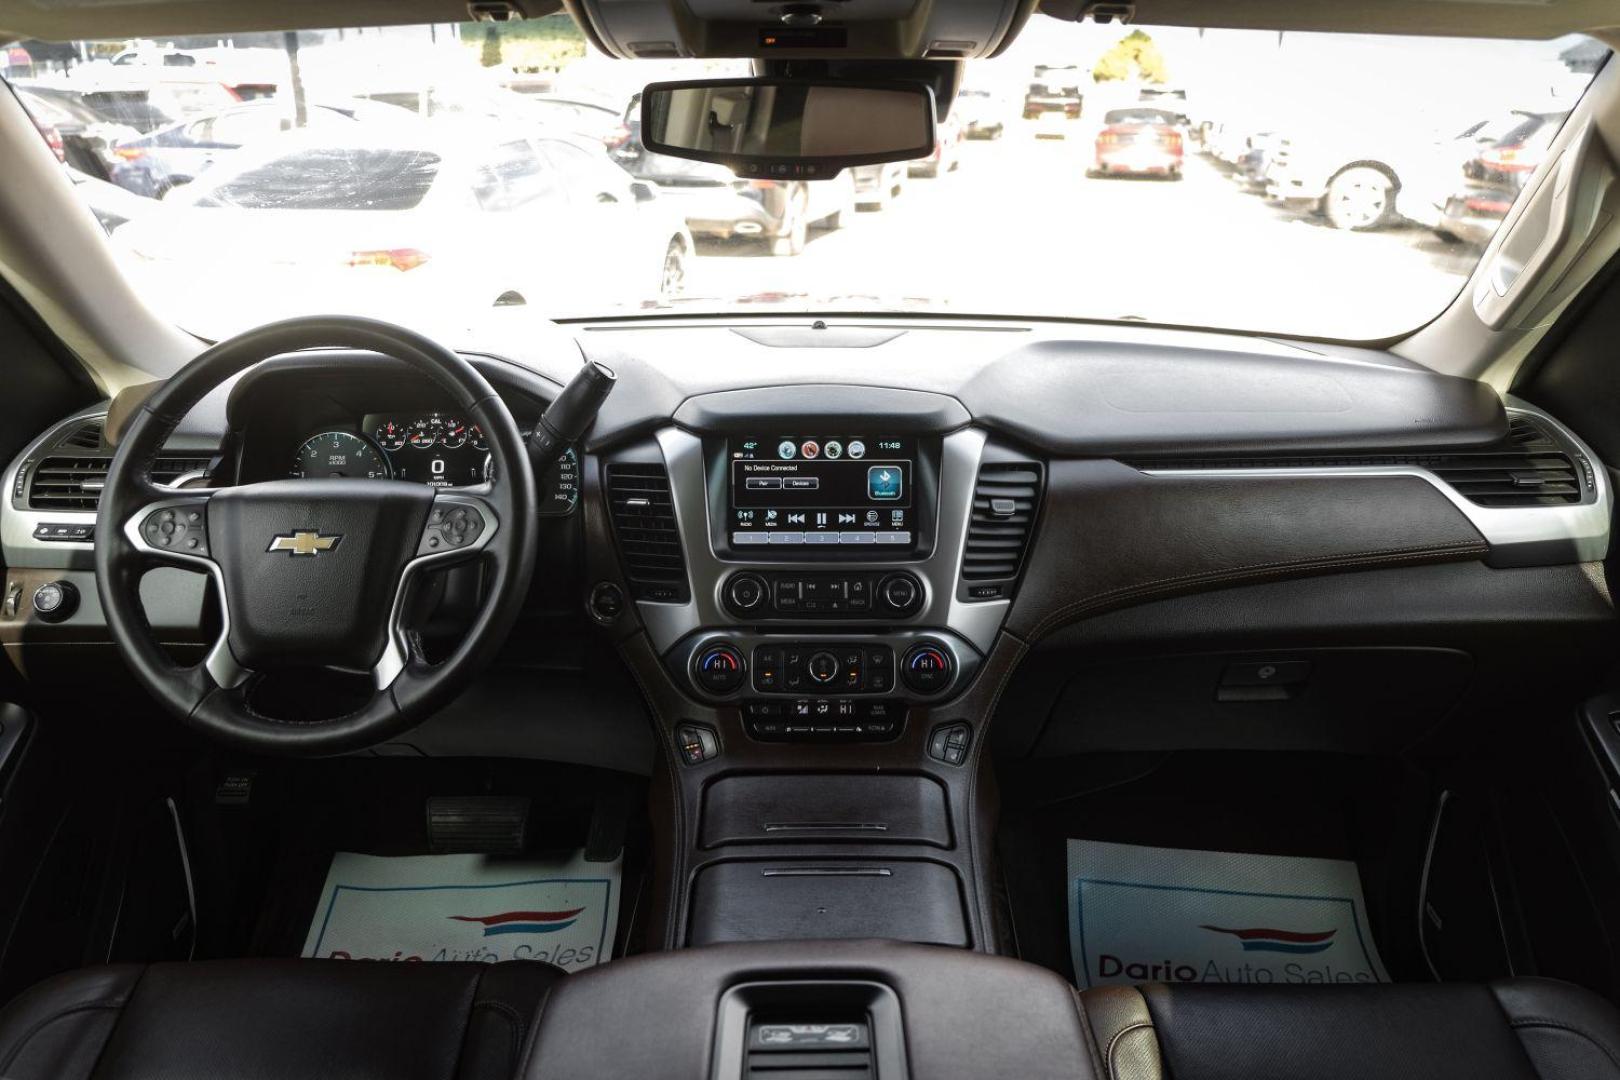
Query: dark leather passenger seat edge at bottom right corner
1081 978 1620 1080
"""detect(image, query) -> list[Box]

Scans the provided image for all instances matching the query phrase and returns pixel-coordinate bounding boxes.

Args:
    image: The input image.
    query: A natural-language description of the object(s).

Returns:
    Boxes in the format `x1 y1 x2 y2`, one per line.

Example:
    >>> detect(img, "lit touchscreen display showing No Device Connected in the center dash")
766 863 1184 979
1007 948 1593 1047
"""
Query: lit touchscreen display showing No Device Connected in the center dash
729 434 917 547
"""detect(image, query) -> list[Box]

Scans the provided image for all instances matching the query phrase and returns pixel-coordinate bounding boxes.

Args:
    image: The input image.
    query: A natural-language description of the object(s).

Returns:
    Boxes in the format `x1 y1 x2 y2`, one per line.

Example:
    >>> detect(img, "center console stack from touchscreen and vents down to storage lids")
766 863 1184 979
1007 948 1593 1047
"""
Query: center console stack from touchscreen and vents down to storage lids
598 387 1042 950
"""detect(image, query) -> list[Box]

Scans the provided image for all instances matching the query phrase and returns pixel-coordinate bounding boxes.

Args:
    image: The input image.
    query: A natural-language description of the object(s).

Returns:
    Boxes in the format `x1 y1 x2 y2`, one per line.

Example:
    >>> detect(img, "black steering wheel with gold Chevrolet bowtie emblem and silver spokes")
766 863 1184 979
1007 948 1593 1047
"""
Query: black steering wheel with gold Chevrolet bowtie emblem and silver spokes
96 316 536 755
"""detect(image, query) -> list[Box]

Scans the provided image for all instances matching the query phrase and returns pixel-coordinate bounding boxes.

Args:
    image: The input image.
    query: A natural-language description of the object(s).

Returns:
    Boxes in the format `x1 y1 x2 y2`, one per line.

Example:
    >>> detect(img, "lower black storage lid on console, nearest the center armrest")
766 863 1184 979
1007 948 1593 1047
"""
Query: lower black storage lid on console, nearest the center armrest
687 858 969 947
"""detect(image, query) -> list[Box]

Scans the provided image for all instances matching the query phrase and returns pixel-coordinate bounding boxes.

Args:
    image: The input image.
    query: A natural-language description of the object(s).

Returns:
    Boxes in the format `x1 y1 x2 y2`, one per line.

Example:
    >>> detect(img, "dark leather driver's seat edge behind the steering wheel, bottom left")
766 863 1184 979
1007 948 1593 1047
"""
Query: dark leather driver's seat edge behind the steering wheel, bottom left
0 960 562 1080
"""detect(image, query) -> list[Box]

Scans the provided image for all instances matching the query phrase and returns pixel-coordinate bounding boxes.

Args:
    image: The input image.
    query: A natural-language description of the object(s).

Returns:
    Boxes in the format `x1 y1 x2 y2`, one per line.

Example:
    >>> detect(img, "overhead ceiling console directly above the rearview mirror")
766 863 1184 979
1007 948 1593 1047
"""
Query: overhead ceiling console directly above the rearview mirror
569 0 1035 60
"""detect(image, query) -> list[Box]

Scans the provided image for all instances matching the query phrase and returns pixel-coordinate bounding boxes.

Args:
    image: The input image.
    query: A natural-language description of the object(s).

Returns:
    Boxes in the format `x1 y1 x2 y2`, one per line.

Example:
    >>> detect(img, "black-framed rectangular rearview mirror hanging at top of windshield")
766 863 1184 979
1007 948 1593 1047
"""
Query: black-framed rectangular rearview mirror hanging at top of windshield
642 79 935 180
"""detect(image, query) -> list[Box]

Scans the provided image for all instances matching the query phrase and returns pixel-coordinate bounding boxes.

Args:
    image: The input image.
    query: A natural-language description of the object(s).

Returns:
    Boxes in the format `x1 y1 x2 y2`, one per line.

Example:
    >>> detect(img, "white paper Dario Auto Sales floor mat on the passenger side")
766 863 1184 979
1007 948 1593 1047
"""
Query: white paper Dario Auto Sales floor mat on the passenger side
1068 840 1388 988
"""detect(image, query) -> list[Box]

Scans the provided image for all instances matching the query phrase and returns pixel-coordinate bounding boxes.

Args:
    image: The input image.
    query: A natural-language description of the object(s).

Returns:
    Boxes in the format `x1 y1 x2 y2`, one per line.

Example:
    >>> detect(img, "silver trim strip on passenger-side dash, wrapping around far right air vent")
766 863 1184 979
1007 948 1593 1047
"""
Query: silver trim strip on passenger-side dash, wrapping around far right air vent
1142 398 1614 567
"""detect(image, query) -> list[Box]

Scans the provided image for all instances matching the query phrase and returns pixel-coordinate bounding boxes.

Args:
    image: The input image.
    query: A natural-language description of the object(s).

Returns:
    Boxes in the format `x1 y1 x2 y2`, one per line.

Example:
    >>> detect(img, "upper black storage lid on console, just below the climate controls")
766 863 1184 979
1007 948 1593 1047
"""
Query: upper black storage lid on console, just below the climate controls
700 774 951 848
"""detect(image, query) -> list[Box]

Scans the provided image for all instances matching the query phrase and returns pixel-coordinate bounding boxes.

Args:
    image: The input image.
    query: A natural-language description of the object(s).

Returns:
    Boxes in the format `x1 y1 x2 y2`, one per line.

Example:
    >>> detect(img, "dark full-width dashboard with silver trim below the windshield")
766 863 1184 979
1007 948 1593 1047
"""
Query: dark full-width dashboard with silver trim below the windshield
0 319 1610 767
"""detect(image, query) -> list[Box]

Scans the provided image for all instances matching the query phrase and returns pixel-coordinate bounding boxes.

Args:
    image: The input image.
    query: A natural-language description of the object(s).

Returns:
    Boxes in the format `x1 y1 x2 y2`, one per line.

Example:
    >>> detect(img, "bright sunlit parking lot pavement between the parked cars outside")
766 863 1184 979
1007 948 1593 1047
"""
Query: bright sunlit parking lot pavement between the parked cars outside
689 123 1477 338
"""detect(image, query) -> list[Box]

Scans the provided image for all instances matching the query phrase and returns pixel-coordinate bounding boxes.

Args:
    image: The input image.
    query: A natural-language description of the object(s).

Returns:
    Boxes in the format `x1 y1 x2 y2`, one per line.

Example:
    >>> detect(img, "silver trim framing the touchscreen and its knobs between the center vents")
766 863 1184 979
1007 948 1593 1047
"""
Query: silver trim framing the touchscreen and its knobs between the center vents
637 427 1011 653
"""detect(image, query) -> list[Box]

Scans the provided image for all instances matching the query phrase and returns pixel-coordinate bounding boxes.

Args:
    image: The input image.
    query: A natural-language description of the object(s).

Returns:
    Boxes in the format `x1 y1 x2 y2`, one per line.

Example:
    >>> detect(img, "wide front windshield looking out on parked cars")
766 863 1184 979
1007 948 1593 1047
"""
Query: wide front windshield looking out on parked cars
0 16 1607 340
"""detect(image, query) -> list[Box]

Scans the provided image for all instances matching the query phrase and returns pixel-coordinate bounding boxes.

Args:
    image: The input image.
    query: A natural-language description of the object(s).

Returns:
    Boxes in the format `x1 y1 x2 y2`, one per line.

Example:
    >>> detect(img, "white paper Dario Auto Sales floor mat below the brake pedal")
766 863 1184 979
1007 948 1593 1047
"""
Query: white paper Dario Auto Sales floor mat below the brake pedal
303 852 619 972
